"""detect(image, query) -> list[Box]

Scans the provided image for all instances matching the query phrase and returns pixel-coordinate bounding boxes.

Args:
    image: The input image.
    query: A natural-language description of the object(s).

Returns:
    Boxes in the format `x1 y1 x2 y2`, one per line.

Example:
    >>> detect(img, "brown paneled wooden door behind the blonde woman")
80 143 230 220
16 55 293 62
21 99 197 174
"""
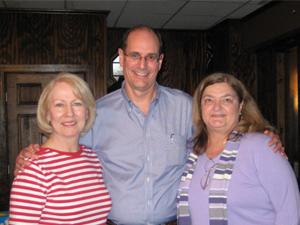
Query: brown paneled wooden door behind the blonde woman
7 73 83 184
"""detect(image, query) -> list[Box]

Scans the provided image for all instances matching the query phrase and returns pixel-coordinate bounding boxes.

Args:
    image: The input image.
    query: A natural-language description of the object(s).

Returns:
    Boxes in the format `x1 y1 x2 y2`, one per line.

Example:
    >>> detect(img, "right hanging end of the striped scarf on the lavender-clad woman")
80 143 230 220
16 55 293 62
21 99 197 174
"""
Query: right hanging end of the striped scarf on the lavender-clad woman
209 132 242 225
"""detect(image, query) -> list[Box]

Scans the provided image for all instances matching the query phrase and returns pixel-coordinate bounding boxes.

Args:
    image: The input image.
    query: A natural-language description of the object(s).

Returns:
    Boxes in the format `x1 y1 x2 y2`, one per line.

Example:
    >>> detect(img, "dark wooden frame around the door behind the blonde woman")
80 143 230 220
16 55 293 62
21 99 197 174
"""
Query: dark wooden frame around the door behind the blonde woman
0 64 95 211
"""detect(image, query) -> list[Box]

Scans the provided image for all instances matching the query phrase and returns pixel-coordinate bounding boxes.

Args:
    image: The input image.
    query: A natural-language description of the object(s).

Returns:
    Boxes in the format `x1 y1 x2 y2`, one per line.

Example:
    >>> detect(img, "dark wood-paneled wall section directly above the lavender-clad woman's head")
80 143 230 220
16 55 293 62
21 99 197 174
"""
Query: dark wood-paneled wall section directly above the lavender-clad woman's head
209 19 257 99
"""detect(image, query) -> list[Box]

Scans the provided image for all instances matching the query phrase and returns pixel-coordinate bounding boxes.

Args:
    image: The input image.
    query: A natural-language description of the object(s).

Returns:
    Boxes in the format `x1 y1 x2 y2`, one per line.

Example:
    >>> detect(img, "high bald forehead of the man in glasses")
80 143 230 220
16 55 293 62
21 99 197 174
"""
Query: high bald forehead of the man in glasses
127 28 159 54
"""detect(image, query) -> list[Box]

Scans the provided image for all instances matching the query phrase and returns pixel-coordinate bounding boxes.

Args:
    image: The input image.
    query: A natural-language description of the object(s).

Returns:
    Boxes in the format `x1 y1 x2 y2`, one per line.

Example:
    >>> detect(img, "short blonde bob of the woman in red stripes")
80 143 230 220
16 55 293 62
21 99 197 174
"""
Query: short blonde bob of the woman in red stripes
37 73 97 137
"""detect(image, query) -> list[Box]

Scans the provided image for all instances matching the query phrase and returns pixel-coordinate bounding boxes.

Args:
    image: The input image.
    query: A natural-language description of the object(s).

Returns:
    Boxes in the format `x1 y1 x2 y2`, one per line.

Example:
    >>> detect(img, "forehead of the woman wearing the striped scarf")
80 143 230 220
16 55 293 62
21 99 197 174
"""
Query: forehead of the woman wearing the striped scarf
202 82 237 97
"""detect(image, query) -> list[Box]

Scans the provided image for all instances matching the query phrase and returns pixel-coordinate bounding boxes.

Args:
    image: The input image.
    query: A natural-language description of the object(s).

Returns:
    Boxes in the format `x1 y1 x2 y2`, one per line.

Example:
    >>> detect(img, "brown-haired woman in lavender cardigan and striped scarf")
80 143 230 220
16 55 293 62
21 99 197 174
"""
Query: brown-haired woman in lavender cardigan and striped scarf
177 73 300 225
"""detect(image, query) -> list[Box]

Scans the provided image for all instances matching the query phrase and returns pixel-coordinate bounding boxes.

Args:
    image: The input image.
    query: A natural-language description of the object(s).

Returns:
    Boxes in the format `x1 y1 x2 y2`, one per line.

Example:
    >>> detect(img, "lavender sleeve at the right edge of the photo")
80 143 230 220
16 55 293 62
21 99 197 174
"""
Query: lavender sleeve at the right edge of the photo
256 137 300 225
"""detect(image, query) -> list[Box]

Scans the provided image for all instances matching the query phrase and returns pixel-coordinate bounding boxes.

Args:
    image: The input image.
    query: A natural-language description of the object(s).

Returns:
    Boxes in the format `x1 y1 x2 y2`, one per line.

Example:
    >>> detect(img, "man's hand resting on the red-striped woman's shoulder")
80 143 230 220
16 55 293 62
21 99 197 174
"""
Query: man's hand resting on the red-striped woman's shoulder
14 144 40 177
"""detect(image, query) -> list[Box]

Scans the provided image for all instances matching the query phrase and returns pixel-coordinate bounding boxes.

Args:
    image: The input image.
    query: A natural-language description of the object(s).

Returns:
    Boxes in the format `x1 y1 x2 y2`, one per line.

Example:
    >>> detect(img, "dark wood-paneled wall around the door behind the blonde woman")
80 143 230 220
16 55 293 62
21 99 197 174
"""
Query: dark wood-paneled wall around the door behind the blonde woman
0 10 107 211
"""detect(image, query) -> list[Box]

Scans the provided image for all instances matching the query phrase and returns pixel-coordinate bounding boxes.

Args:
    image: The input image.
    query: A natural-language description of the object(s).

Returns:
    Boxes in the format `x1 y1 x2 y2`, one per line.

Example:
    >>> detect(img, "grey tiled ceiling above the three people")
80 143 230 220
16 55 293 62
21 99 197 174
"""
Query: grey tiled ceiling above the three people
0 0 271 30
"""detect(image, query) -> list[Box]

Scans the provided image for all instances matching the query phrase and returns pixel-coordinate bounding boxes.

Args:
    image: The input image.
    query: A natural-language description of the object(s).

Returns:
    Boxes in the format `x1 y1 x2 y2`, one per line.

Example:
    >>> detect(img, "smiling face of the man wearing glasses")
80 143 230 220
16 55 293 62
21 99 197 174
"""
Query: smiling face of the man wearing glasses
119 29 163 94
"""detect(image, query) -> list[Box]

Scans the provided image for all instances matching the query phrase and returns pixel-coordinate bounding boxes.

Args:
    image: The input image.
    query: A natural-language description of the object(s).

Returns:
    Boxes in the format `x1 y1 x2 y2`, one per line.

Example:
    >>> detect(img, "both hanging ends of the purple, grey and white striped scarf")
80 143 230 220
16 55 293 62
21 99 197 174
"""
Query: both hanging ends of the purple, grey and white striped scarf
177 131 243 225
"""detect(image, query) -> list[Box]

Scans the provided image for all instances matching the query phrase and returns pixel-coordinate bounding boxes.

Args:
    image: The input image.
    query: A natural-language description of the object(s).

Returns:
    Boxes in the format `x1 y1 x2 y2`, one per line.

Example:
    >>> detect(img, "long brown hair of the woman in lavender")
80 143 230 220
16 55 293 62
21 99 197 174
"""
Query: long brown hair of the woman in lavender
191 73 276 155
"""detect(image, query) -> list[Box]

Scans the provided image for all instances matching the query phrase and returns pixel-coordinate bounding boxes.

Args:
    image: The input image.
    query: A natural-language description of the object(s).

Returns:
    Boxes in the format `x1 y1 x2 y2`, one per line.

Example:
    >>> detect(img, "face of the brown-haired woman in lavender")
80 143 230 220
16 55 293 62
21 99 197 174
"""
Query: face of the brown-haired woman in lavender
201 83 243 135
